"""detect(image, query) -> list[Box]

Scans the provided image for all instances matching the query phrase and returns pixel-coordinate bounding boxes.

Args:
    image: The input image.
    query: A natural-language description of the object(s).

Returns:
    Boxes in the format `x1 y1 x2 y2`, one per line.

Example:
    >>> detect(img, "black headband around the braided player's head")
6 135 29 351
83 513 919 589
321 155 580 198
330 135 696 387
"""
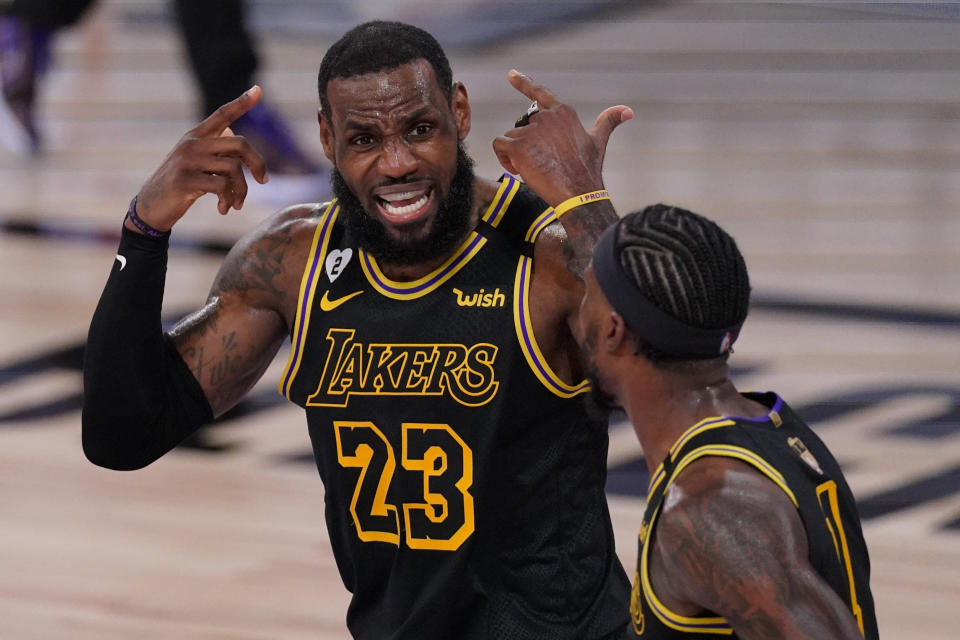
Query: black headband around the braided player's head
593 220 743 358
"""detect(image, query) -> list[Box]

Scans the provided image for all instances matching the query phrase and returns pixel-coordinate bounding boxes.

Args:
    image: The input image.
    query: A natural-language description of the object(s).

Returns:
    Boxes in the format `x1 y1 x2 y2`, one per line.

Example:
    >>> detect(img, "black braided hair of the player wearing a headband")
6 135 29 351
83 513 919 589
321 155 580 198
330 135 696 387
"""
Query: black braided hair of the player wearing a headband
615 204 750 365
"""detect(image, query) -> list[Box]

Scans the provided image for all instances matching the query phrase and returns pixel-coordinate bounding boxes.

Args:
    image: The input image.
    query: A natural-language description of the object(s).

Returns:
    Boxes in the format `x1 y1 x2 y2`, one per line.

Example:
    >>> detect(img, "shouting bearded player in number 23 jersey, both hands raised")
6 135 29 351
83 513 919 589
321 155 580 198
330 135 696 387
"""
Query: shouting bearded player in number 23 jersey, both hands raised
83 22 632 640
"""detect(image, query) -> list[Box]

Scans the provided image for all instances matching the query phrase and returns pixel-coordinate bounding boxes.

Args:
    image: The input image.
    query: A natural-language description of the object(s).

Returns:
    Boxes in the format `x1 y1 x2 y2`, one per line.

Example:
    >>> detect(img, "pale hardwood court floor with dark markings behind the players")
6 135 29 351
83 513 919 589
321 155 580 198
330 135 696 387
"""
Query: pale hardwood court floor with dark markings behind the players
0 0 960 640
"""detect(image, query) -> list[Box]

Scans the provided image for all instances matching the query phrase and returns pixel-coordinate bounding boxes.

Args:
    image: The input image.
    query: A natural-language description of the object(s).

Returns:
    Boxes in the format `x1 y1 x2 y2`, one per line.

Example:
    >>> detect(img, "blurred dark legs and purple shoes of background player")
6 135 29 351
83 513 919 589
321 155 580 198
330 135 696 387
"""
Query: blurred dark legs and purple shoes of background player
0 0 329 202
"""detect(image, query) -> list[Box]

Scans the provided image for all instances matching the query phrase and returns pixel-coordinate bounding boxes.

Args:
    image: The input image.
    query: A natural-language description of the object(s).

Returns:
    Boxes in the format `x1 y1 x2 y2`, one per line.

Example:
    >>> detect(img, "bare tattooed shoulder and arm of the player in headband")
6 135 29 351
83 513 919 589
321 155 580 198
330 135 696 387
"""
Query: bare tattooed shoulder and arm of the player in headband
653 465 858 640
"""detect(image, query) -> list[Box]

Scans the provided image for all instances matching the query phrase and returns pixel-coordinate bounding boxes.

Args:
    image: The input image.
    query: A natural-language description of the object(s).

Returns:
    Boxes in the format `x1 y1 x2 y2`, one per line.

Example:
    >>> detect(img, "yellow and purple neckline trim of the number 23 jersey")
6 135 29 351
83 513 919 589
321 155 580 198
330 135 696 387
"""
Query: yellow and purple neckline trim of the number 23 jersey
358 174 520 300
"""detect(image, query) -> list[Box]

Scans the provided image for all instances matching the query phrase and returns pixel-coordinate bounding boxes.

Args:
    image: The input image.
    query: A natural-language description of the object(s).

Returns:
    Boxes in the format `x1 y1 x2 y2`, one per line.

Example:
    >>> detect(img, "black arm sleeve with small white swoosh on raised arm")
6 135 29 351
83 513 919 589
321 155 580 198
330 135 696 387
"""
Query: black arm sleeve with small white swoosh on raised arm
82 228 213 470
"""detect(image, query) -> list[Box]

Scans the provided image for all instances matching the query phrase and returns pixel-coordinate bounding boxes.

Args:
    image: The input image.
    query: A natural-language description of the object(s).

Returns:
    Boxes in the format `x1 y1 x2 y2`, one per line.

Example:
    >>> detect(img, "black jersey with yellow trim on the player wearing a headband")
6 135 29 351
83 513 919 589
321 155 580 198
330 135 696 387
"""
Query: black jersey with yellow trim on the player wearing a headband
630 393 877 640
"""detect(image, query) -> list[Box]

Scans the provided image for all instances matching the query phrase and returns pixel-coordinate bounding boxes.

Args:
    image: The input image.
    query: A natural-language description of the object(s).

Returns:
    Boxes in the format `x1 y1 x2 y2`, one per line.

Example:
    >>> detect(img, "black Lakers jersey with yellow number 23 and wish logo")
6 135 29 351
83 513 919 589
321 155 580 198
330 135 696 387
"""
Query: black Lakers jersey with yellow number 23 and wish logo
280 176 629 640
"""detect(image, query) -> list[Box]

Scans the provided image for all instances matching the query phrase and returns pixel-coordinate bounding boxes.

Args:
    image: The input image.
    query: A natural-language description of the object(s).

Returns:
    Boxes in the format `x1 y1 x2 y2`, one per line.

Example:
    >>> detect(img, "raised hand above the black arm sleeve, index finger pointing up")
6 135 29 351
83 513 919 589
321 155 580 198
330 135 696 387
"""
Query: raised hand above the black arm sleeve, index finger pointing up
128 85 268 231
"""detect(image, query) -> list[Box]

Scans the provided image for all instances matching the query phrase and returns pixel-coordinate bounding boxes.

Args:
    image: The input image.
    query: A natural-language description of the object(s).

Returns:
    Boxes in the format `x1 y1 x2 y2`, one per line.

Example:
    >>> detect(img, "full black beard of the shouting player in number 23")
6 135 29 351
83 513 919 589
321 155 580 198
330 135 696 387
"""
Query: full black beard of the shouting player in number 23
330 143 474 266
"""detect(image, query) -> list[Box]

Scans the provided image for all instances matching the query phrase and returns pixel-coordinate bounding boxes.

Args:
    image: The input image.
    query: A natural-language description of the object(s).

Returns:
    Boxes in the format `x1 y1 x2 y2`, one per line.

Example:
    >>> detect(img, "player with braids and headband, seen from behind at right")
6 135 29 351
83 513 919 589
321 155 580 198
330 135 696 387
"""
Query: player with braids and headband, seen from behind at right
578 205 877 640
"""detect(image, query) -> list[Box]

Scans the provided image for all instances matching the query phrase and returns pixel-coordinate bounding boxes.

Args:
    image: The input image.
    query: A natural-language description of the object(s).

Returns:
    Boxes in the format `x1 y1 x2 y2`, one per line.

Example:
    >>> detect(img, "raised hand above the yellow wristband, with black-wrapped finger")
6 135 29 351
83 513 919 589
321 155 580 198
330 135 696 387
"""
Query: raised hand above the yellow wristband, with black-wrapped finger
493 69 633 205
